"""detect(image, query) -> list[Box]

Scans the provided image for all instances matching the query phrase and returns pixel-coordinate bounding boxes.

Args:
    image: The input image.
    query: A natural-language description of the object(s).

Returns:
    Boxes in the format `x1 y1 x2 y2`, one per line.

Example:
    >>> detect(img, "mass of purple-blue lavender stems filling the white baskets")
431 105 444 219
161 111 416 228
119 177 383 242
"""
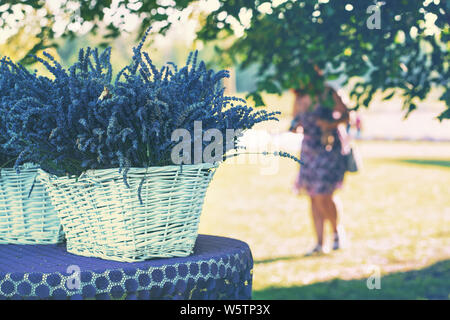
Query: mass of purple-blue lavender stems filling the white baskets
0 33 278 182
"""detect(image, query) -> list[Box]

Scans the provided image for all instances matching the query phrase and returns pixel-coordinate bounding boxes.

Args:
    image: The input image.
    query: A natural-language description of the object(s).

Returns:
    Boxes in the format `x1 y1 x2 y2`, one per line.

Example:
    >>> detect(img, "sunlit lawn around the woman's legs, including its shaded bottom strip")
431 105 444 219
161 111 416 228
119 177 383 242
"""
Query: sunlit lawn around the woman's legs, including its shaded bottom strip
200 142 450 299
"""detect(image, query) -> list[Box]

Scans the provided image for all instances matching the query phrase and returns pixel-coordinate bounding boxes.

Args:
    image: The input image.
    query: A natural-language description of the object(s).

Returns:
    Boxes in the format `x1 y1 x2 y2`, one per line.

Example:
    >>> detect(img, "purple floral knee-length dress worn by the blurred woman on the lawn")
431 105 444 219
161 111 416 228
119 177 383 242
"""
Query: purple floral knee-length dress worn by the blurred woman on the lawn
294 106 346 195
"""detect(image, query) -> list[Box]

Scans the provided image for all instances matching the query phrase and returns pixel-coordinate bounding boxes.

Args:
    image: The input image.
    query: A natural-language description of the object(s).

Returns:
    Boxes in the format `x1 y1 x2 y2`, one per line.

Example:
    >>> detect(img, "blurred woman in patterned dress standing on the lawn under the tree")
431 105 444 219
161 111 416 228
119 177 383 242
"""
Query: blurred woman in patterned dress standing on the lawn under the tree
291 87 350 255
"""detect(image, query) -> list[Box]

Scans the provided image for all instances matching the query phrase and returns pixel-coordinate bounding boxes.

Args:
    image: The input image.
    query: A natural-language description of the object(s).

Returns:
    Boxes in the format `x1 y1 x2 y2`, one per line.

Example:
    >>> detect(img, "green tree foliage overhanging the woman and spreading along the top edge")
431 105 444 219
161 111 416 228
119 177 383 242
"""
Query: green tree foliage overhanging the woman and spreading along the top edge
0 0 450 120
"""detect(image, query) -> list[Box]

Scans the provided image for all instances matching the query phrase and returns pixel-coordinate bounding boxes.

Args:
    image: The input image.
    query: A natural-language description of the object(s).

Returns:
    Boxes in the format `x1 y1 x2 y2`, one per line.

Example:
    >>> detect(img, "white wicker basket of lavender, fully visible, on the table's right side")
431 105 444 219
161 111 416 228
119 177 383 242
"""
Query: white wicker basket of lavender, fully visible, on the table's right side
40 163 217 262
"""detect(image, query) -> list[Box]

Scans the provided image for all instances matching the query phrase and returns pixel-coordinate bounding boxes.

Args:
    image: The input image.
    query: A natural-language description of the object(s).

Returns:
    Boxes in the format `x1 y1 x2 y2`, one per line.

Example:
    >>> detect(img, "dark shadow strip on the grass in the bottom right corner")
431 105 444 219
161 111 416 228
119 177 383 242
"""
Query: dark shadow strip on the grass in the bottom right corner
253 260 450 300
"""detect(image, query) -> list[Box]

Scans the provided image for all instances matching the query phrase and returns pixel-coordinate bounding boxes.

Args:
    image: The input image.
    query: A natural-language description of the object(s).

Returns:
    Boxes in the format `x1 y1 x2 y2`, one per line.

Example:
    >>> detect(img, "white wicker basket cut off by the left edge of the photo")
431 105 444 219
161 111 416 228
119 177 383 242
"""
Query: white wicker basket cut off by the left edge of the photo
0 165 64 244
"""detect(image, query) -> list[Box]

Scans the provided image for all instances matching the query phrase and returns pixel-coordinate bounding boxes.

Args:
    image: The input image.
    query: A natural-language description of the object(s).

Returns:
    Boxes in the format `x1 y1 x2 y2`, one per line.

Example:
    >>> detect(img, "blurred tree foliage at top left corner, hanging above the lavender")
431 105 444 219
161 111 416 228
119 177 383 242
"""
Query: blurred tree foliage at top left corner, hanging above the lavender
0 0 192 64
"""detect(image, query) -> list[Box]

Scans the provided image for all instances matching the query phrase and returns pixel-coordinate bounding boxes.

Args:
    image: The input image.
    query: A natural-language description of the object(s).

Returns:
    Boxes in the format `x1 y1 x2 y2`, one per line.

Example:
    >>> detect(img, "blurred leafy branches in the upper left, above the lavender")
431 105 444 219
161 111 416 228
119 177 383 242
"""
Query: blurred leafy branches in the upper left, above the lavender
0 0 192 64
